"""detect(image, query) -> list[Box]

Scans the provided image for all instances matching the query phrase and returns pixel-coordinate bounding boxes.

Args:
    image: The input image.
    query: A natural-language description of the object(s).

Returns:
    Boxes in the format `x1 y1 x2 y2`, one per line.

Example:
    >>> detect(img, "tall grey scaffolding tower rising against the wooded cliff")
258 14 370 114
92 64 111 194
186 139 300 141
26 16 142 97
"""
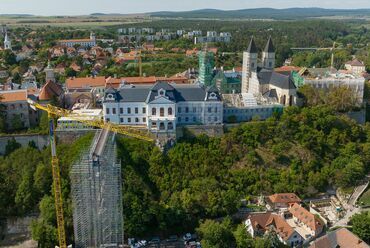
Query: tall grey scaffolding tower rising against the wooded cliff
70 130 123 248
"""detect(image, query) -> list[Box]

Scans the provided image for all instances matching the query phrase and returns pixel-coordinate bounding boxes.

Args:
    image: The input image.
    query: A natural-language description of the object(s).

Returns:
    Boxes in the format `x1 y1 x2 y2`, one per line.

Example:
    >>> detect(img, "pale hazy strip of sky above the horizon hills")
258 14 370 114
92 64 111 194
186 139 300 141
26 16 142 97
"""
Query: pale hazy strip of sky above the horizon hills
0 0 370 15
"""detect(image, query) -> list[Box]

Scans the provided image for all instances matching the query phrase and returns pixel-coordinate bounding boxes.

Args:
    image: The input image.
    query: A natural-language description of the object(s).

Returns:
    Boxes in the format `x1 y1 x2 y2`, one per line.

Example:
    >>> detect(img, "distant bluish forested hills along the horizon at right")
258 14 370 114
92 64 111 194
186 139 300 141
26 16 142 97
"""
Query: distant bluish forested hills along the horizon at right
150 8 370 20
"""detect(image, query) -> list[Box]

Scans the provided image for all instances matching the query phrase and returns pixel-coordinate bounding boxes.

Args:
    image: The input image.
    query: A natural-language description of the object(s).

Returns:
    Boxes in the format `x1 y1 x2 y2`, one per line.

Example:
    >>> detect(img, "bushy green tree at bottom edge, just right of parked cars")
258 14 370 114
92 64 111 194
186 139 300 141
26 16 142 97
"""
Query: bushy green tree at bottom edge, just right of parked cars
196 218 236 248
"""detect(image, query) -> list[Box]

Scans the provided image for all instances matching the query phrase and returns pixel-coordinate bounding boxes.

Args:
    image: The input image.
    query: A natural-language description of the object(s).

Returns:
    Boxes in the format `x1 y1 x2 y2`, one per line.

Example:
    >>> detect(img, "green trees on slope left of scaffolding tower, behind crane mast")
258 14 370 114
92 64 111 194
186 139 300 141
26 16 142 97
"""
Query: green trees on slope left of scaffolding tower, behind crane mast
0 134 92 247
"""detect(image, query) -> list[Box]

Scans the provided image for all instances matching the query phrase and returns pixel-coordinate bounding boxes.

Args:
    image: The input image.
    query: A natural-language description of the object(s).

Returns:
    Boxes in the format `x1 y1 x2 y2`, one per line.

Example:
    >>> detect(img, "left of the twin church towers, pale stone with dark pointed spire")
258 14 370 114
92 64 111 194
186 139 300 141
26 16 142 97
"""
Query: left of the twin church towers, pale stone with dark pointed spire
241 37 258 93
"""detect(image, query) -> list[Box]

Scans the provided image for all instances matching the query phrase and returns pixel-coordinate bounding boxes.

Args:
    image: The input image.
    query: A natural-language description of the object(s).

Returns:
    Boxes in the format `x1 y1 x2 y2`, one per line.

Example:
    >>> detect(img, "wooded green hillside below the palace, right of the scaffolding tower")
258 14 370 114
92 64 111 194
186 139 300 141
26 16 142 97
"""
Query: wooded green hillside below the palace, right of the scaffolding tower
119 107 370 236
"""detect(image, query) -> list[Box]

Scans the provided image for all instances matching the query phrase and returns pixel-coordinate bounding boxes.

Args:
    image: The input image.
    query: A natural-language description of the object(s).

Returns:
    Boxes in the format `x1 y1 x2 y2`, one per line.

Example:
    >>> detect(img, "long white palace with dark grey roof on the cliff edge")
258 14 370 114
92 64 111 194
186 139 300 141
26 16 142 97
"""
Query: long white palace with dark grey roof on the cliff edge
103 82 223 132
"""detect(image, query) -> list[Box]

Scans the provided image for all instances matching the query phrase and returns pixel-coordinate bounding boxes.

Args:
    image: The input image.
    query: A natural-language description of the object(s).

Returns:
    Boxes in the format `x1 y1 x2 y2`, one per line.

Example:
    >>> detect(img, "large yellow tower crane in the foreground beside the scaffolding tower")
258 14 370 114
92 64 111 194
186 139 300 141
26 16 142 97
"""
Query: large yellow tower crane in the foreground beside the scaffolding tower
28 99 154 248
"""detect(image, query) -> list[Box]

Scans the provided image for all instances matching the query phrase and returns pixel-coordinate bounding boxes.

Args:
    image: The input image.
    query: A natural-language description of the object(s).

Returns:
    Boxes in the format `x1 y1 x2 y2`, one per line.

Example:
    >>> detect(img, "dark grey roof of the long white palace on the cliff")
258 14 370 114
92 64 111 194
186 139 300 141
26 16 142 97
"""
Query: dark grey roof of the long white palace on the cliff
114 82 220 103
